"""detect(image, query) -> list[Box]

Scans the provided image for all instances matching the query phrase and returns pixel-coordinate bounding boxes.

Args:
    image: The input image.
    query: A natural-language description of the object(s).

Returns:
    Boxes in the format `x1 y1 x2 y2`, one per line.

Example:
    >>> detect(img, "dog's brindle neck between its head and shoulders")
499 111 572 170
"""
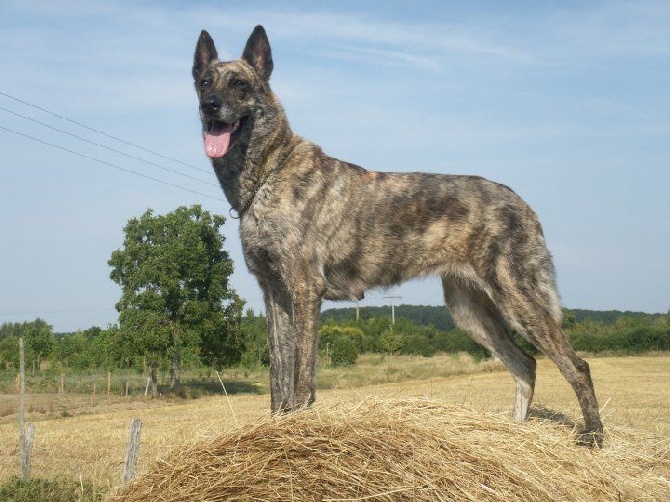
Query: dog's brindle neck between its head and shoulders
212 95 296 216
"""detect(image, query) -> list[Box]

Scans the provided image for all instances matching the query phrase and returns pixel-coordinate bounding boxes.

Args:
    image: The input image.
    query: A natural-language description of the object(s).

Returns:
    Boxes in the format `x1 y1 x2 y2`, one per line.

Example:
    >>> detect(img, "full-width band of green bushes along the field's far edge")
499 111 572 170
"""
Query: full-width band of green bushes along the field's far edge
0 306 670 371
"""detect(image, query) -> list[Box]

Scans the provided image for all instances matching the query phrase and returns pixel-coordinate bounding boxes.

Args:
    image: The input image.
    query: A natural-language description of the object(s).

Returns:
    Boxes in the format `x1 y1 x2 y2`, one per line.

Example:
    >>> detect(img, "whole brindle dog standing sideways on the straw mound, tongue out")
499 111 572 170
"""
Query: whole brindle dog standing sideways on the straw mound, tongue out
193 26 603 444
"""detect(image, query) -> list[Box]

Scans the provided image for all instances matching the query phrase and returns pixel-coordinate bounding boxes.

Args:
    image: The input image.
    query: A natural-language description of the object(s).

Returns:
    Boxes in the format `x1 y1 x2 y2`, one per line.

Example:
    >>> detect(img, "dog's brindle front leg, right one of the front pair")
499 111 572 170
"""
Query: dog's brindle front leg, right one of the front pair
293 289 321 409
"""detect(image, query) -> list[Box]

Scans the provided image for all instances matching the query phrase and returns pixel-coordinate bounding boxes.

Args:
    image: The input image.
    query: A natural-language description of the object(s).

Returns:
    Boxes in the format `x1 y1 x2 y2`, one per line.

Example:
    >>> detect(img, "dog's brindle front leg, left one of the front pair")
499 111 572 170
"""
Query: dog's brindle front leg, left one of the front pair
261 280 295 414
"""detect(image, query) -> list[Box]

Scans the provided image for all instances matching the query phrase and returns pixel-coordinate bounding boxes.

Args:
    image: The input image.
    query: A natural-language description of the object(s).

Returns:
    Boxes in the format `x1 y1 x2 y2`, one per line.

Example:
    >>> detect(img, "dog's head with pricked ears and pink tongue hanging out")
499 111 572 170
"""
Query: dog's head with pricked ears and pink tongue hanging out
193 26 273 158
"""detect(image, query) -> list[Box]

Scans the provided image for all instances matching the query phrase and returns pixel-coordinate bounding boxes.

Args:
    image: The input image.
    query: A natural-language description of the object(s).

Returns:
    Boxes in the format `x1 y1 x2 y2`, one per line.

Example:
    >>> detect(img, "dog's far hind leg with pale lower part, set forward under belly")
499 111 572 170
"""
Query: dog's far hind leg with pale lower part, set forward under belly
442 277 536 421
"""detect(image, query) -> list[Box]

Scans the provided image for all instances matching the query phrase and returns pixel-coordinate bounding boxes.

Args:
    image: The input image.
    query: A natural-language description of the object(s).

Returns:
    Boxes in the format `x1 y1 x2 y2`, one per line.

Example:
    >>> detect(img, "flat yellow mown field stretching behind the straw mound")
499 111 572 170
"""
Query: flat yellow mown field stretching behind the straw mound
0 355 670 495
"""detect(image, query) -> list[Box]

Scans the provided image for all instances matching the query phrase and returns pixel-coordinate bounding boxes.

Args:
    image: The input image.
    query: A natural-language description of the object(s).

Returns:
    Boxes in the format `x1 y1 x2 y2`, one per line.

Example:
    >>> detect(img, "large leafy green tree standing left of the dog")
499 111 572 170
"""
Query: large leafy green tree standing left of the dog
108 205 243 389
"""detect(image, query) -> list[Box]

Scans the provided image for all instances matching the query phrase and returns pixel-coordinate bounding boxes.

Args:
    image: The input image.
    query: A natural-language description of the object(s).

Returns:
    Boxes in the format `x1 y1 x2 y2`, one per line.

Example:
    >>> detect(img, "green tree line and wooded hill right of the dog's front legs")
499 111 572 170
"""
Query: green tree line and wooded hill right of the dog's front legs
321 305 670 364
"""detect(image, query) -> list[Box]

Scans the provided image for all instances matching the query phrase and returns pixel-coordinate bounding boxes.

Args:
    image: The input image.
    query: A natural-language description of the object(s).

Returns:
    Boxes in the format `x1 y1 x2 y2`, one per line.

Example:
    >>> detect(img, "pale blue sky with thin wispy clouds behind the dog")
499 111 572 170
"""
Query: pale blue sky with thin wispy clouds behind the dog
0 0 670 332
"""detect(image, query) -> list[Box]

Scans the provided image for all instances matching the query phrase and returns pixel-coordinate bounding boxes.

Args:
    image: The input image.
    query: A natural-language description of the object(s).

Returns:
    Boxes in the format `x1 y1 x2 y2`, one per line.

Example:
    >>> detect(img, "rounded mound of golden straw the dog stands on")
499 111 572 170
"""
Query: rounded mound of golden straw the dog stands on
113 399 670 502
